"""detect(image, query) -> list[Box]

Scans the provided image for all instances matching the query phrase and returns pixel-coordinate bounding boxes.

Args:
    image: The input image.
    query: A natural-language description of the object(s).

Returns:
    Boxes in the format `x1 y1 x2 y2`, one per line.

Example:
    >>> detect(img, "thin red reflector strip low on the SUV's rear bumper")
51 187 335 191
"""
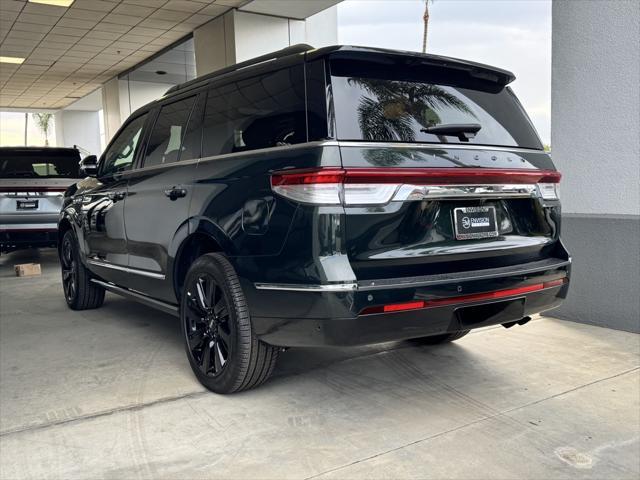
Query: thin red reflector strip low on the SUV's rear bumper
360 278 567 315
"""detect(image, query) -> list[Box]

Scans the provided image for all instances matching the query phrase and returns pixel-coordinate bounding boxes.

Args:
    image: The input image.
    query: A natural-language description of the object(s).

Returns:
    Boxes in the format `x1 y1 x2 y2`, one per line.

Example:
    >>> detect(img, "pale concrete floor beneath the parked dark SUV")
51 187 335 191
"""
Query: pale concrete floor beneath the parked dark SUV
0 251 640 480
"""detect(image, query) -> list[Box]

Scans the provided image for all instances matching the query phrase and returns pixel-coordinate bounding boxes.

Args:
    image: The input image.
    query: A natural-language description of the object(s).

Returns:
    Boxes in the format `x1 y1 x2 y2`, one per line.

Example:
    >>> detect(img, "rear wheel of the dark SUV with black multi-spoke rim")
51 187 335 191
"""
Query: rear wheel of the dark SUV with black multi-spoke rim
180 253 279 393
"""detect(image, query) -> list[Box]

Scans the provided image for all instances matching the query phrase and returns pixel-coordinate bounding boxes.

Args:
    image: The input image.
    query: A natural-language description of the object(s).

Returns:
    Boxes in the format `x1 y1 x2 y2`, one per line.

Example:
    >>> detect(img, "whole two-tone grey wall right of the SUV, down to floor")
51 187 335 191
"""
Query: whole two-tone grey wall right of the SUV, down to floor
551 0 640 332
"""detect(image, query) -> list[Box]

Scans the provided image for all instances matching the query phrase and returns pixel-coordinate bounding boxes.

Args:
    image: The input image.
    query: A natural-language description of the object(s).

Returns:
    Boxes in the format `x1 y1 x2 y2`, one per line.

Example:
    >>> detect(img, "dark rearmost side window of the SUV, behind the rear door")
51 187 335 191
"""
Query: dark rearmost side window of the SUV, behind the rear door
202 65 307 157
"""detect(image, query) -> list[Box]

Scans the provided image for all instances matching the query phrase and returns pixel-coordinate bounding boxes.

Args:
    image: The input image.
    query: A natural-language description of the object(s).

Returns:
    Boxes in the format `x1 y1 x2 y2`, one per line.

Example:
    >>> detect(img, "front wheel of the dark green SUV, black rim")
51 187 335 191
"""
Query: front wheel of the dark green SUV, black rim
58 230 104 310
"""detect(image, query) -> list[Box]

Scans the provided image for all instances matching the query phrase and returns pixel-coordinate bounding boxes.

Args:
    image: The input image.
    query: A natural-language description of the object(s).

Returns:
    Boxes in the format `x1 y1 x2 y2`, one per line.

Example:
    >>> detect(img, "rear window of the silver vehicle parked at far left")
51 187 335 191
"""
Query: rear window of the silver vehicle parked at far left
0 149 81 178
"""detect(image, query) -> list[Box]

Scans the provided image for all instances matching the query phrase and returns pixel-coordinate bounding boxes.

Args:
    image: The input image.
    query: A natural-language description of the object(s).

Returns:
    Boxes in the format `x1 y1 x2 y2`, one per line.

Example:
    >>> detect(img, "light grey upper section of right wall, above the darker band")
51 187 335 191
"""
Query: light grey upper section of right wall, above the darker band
551 0 640 215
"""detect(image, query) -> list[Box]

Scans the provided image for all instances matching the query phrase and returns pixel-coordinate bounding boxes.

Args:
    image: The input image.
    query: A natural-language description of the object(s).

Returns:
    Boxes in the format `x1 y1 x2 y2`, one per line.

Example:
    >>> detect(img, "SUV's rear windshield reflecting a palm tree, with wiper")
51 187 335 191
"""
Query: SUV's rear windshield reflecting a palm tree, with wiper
331 65 542 149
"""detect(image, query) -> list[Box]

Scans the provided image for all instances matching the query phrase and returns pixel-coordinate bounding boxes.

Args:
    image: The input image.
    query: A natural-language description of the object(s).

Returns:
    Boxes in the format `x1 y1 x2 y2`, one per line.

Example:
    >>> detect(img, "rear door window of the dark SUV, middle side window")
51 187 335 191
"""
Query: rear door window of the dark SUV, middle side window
142 97 196 167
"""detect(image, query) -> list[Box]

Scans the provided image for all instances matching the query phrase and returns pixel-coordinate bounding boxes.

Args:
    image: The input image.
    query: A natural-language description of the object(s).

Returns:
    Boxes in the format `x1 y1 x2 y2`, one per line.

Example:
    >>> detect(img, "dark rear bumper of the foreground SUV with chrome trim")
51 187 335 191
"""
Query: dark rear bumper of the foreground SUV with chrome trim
243 258 570 347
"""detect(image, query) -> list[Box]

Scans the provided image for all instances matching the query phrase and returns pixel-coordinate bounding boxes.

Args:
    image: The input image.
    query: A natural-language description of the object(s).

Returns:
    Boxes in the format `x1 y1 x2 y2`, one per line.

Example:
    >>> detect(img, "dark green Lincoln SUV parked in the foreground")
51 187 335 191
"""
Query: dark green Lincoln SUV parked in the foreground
59 45 570 393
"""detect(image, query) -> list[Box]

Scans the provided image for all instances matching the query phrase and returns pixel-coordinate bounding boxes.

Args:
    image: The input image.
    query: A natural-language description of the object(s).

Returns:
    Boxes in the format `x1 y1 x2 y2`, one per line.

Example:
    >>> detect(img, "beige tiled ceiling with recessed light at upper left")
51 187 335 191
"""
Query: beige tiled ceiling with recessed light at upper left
0 0 249 108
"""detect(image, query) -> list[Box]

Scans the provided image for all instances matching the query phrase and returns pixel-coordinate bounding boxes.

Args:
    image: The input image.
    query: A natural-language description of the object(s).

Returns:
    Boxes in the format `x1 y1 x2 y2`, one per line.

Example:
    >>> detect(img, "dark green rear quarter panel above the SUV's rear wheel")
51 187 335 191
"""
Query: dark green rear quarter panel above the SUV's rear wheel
190 145 340 263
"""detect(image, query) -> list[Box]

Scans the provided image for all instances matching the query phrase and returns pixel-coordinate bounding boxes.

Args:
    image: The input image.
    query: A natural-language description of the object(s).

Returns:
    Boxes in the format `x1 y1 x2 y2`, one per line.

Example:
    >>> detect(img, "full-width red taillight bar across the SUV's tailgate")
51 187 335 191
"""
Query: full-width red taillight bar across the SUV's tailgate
271 167 562 186
